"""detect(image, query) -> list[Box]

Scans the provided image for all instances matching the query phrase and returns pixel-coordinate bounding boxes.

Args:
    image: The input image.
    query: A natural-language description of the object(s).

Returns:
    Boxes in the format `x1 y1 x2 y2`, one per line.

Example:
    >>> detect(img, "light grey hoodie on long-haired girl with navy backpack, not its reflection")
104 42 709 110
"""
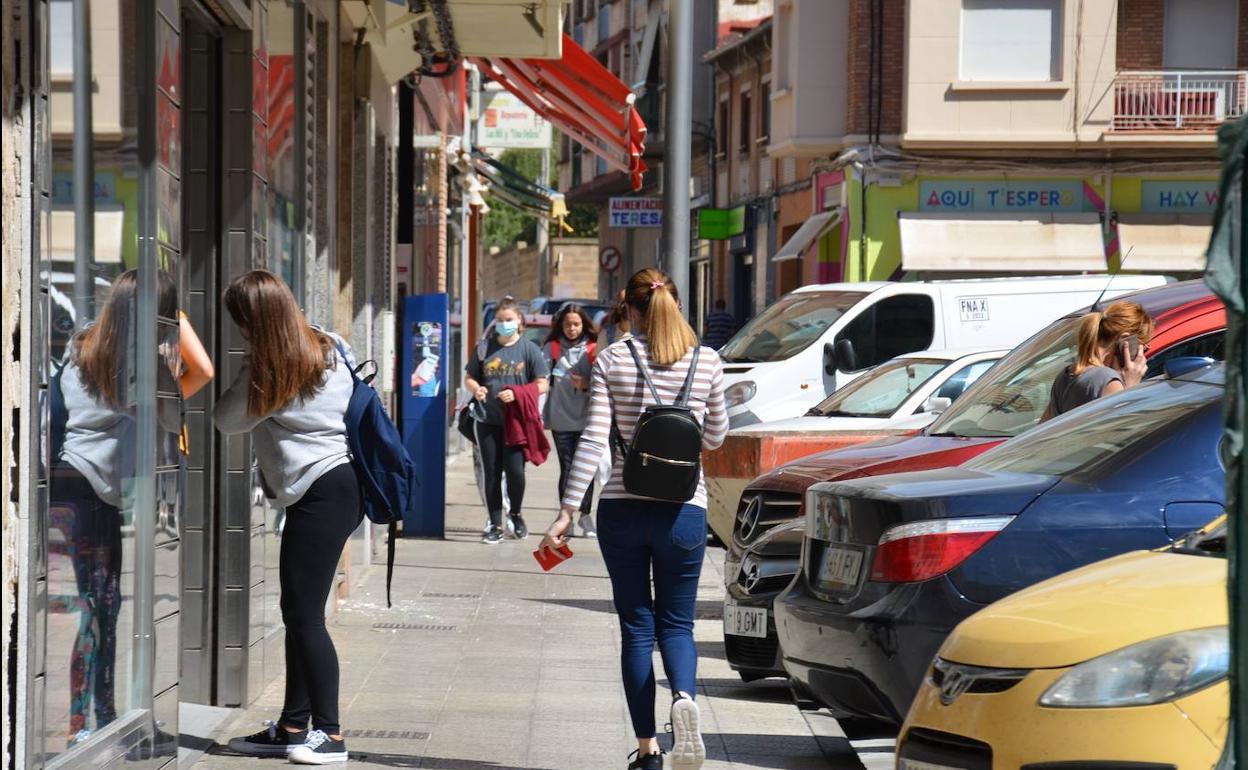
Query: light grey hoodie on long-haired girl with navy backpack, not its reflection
212 332 356 505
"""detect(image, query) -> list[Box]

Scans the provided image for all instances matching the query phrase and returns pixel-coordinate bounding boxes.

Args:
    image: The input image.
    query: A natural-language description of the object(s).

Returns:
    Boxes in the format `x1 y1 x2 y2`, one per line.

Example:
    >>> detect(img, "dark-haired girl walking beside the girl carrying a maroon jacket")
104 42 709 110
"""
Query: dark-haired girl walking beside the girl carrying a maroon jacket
543 305 598 538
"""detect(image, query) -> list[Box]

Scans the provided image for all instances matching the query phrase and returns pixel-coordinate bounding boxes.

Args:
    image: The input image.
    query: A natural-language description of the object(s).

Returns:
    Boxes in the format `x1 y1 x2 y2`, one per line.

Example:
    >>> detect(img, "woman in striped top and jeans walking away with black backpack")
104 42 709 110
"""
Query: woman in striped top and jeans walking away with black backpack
542 270 728 770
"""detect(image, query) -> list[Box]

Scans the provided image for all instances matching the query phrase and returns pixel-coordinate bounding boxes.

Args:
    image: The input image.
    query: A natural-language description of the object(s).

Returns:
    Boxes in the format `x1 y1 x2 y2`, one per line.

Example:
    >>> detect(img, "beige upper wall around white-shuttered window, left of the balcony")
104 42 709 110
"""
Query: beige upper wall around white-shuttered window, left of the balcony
902 0 1118 147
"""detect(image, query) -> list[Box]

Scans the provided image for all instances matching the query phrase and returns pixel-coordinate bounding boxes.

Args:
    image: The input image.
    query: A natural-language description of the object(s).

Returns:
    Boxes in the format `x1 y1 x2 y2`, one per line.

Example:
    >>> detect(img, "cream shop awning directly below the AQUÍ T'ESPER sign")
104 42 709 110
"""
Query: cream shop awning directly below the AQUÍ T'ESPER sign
899 212 1106 272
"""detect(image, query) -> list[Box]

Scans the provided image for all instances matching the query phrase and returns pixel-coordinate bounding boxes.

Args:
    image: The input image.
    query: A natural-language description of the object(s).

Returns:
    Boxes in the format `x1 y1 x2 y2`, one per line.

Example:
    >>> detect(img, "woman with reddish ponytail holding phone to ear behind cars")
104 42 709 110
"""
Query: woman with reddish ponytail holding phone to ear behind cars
1042 300 1153 419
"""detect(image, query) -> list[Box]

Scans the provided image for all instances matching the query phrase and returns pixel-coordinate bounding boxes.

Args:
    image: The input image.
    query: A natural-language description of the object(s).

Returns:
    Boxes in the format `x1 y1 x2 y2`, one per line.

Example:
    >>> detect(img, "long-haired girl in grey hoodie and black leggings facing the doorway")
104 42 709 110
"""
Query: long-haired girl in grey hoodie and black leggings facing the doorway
213 270 363 765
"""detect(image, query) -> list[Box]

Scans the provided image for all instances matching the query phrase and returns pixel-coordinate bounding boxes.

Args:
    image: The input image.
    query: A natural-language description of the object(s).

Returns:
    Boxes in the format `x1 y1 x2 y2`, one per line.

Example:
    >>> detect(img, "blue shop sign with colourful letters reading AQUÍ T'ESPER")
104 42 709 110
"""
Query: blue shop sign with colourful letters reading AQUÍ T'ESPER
919 180 1092 212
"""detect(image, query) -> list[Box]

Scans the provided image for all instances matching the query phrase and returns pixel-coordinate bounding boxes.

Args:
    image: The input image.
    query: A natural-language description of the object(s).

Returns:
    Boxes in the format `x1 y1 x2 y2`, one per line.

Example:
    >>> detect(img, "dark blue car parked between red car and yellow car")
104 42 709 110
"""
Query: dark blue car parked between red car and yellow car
775 364 1226 723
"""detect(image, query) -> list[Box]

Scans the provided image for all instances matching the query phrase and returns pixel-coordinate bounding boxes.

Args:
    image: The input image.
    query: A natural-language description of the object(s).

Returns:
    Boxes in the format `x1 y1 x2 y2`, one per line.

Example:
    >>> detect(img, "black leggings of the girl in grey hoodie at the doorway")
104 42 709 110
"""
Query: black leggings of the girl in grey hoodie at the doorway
280 463 363 735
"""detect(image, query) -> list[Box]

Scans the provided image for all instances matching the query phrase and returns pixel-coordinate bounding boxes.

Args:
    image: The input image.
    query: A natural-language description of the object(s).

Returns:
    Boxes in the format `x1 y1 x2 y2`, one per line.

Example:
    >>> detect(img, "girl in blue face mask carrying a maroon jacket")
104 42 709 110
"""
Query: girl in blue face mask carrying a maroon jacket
464 298 550 544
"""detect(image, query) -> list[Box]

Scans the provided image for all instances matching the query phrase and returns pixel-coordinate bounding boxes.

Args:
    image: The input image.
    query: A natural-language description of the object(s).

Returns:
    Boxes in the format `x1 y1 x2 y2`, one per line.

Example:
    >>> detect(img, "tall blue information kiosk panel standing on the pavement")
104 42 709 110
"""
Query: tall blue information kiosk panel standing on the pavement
398 295 454 538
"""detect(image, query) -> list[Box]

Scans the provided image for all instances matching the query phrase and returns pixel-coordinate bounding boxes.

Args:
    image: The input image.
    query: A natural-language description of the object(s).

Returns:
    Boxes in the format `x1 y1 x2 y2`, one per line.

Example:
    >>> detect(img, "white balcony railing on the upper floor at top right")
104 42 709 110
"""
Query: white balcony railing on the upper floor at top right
1113 70 1248 131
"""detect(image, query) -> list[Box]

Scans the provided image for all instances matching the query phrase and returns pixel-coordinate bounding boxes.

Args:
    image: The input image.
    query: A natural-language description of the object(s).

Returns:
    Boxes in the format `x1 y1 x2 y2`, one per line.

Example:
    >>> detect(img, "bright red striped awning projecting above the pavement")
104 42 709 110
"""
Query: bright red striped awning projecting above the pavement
473 35 645 190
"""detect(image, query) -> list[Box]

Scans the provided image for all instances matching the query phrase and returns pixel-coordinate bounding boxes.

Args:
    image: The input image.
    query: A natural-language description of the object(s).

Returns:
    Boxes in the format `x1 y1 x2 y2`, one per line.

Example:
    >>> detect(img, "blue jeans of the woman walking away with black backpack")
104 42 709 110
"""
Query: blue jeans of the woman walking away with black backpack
598 499 706 739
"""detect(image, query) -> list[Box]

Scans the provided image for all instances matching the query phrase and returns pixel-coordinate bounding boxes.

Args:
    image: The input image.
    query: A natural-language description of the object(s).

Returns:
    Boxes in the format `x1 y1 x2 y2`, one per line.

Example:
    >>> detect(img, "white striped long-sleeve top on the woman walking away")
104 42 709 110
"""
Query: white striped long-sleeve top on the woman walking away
563 337 728 508
